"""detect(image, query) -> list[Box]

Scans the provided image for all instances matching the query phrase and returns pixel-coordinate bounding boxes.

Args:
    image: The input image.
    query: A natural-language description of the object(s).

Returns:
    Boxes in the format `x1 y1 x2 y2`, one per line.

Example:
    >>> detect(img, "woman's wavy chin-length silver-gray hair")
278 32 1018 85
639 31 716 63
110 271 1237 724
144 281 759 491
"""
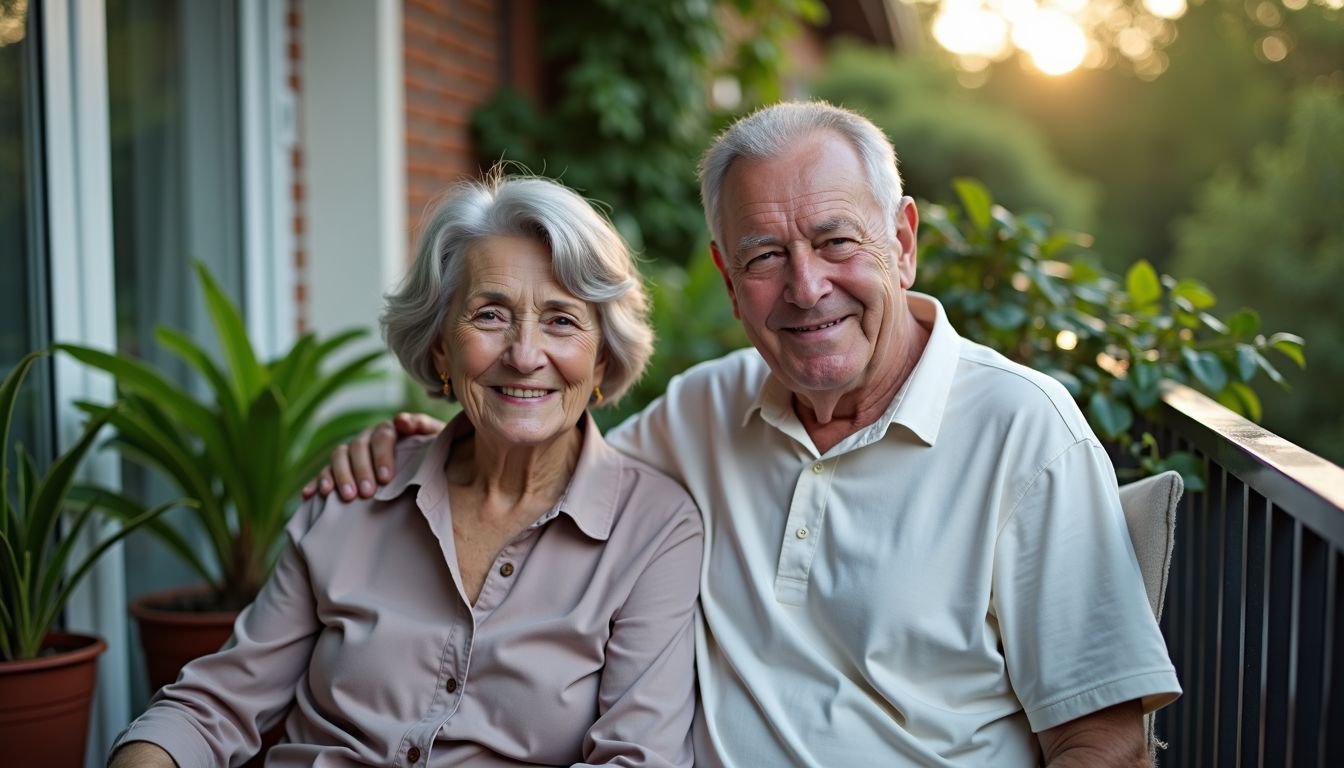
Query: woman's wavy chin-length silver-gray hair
380 172 653 405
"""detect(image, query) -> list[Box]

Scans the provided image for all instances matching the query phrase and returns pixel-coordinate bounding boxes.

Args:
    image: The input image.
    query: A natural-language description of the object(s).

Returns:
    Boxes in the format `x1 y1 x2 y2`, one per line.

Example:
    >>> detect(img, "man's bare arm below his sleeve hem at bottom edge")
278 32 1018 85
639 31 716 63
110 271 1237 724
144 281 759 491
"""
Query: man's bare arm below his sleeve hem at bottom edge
1036 699 1152 768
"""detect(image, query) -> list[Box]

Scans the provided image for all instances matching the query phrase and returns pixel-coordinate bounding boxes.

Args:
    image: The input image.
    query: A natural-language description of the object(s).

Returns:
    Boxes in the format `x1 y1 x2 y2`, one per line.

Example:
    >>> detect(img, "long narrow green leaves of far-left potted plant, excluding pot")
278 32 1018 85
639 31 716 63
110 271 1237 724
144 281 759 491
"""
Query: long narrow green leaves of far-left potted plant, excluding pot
0 352 177 660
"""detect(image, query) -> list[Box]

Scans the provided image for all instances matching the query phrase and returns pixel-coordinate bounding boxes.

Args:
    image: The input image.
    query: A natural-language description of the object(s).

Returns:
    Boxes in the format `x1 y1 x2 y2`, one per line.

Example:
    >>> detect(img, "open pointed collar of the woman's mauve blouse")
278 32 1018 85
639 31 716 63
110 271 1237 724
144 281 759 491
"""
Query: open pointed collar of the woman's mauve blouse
374 412 625 541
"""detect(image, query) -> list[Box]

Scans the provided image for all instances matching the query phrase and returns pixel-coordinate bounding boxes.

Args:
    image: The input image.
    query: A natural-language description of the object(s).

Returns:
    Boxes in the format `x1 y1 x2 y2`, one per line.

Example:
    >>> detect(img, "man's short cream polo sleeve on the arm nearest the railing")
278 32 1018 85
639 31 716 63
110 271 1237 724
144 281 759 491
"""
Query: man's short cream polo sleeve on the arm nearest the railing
993 440 1180 733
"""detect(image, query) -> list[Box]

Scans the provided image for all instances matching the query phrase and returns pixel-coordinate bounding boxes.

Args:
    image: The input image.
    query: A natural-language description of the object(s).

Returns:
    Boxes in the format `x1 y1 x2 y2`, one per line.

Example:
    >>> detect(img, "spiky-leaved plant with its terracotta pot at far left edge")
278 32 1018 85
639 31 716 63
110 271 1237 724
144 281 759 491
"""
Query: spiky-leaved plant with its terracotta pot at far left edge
0 352 175 767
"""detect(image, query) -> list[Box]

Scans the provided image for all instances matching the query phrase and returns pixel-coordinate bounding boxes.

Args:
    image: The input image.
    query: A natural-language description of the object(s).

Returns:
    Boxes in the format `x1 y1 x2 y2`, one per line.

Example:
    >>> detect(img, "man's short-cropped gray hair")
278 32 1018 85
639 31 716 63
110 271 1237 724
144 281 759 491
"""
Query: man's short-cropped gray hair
700 101 900 247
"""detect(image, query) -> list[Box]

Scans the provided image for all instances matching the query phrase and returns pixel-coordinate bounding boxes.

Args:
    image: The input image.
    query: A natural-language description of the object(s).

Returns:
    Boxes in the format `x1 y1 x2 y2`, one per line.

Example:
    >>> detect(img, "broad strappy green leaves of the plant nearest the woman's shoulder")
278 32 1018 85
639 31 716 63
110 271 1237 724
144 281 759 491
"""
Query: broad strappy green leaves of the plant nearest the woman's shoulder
58 264 388 608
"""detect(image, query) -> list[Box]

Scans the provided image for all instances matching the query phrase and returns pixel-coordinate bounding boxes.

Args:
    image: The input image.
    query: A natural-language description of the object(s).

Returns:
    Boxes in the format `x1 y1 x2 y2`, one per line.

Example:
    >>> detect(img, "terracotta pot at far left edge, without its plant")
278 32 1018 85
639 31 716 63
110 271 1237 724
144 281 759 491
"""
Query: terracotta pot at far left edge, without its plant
0 632 108 768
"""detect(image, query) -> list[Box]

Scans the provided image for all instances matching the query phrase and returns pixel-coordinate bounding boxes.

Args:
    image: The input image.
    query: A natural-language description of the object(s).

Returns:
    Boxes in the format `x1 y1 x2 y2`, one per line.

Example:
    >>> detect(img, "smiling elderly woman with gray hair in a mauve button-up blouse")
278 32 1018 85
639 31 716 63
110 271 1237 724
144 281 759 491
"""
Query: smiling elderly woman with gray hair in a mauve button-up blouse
113 178 703 768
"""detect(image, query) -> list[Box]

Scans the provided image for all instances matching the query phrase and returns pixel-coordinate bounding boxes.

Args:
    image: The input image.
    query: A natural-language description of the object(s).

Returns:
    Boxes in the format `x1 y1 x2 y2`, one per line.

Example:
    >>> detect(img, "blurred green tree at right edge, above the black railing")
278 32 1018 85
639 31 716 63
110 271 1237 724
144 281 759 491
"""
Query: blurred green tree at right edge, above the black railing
1176 86 1344 463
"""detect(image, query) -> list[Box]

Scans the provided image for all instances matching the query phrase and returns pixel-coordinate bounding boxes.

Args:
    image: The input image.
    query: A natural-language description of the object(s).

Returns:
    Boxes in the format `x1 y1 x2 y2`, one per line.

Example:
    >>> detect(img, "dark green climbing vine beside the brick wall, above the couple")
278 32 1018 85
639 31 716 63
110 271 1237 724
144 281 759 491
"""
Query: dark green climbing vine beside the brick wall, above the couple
472 0 825 261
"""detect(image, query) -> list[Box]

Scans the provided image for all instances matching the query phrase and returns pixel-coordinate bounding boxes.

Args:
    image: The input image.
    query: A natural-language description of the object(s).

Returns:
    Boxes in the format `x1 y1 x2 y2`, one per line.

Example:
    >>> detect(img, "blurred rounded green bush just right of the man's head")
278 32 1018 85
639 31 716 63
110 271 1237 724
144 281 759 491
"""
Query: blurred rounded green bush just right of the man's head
812 44 1097 230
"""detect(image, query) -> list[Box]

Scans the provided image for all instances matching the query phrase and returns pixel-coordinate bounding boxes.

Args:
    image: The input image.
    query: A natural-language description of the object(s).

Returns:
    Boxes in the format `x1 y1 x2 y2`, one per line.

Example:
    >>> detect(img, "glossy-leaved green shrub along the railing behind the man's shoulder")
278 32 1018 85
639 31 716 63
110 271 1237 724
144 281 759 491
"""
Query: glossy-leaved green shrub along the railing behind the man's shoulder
917 179 1305 488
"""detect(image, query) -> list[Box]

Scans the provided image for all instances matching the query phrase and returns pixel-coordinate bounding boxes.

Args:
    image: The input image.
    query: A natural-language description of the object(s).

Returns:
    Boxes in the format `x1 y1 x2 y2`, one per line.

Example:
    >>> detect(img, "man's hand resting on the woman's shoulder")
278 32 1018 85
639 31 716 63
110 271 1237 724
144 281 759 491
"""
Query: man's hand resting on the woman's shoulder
304 413 444 502
